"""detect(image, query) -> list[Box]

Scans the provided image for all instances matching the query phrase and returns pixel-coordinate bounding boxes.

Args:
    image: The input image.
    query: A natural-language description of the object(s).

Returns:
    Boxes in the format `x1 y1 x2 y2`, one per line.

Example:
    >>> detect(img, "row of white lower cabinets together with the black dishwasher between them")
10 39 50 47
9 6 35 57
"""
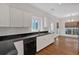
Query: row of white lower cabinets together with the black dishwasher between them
14 34 55 55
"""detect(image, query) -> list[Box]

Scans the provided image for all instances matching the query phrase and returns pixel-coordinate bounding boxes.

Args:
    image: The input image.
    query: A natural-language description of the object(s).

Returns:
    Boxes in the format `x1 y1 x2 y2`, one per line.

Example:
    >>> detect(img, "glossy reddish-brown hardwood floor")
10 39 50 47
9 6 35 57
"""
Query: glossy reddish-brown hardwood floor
36 36 79 55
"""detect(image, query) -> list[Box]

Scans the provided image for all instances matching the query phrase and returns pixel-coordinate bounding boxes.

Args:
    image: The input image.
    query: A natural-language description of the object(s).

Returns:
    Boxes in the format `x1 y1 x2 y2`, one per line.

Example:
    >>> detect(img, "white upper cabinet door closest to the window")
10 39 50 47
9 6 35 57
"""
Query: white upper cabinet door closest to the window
24 12 32 27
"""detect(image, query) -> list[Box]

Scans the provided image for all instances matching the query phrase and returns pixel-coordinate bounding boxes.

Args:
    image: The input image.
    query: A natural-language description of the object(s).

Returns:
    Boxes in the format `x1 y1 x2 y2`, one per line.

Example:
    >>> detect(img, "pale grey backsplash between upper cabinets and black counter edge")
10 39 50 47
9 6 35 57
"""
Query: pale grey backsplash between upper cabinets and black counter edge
0 27 31 36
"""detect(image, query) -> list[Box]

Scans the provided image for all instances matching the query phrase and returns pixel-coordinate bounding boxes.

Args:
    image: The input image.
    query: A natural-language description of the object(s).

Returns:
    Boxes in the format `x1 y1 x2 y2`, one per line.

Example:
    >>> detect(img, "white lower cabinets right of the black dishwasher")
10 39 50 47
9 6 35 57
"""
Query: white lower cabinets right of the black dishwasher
36 34 55 52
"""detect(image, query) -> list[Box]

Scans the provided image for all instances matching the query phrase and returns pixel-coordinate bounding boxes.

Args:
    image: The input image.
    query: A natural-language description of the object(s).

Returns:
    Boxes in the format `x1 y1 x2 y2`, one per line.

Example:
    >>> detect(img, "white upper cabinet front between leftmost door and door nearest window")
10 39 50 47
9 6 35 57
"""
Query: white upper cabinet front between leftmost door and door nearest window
10 8 23 27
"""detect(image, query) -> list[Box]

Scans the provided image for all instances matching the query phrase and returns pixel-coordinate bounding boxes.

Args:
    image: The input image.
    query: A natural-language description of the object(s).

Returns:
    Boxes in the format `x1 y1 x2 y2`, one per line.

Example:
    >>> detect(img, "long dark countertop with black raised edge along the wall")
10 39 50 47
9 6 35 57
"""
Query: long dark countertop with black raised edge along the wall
0 31 49 41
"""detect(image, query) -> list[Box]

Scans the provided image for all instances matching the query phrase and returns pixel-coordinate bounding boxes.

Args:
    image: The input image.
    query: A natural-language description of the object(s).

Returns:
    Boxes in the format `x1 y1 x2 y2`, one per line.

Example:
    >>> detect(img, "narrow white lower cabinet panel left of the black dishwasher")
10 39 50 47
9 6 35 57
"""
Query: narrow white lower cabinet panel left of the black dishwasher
14 40 24 55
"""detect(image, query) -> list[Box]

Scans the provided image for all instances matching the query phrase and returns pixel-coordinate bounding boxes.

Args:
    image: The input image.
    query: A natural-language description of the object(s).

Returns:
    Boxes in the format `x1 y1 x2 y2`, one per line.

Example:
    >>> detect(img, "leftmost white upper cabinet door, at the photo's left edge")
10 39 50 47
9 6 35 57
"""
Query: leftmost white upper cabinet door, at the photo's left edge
0 4 10 27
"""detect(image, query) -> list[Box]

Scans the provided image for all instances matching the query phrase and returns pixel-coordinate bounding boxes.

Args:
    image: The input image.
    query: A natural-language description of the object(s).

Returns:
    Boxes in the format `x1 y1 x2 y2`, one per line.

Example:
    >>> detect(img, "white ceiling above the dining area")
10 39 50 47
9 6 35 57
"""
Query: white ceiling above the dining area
31 3 79 17
